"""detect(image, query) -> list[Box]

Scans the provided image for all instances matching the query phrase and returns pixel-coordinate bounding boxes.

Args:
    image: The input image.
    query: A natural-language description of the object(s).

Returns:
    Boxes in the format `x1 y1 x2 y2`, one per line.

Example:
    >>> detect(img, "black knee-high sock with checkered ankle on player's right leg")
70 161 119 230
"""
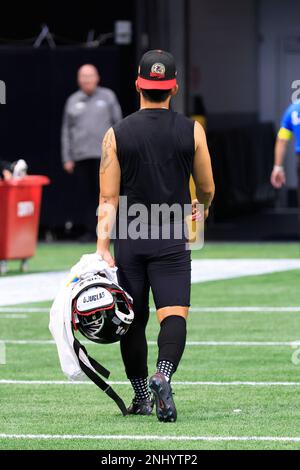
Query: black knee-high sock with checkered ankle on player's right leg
157 315 186 380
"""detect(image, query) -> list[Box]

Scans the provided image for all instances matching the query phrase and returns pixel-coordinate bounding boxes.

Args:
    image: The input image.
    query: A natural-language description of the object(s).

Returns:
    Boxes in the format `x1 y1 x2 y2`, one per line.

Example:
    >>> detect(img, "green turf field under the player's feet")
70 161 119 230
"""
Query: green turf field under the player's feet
0 244 300 450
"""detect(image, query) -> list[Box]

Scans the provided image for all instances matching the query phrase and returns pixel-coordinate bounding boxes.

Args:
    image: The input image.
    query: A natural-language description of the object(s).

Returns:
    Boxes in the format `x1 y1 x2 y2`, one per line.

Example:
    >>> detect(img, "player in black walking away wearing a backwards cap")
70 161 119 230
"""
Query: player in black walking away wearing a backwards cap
97 50 215 422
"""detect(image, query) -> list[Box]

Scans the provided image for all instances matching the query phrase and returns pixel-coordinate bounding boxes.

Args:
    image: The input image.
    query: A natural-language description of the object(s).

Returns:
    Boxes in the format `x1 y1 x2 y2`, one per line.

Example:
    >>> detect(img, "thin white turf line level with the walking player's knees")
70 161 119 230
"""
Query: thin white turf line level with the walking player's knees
0 306 300 313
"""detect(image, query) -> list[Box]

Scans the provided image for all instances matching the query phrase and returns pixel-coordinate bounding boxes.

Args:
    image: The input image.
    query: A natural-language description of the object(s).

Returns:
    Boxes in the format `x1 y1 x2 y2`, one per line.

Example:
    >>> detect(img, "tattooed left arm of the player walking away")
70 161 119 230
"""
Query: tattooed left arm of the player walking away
97 128 121 266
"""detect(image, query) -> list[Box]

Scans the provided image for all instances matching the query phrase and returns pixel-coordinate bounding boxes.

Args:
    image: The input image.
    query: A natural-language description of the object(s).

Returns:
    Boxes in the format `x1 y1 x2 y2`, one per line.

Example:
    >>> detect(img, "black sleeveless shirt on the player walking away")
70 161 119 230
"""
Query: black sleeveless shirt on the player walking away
113 109 195 215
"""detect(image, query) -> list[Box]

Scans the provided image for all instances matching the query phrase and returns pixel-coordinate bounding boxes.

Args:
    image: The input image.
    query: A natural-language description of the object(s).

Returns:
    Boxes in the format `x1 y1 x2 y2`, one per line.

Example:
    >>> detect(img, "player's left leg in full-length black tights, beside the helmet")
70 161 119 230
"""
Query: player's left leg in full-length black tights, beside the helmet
115 240 153 415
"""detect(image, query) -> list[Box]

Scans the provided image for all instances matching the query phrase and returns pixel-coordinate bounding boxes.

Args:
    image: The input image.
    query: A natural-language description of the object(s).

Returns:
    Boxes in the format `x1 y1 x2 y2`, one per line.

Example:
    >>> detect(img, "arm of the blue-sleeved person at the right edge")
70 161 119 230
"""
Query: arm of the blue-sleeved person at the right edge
271 109 293 189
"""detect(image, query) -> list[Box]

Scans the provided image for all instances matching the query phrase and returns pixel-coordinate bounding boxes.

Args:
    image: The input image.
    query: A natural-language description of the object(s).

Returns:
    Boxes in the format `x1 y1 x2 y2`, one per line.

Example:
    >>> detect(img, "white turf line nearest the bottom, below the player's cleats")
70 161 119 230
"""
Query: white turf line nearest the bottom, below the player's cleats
0 434 300 442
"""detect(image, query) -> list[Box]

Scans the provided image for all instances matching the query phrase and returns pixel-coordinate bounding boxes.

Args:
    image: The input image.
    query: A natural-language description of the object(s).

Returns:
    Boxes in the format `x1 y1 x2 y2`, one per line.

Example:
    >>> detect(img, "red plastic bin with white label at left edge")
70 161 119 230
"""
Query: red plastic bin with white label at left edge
0 176 50 274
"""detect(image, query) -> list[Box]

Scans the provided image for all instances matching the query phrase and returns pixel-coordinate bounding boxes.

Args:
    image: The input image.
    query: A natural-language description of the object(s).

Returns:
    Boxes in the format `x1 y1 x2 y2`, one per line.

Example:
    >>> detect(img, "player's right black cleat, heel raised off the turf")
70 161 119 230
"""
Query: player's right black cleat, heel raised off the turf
149 372 177 423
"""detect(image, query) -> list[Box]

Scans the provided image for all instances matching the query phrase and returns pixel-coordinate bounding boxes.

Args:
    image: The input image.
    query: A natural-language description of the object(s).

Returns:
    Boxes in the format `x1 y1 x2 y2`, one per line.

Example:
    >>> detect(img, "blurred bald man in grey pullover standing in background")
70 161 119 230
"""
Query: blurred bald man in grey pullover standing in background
62 64 122 242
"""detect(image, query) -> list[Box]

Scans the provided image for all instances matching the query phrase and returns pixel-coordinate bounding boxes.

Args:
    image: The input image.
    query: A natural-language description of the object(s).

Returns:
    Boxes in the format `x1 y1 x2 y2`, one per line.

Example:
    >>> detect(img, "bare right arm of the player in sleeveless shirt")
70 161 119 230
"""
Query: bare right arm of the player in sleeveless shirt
193 122 215 217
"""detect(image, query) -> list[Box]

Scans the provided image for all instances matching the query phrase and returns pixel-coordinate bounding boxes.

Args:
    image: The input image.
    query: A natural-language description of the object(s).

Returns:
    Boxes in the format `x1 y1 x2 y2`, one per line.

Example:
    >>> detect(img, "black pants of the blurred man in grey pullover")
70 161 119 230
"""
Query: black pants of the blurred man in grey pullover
75 158 100 235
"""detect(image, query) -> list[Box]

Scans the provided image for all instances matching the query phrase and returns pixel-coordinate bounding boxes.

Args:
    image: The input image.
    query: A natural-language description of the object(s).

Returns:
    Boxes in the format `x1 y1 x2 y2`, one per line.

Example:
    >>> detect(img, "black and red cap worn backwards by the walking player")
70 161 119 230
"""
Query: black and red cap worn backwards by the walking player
137 50 177 90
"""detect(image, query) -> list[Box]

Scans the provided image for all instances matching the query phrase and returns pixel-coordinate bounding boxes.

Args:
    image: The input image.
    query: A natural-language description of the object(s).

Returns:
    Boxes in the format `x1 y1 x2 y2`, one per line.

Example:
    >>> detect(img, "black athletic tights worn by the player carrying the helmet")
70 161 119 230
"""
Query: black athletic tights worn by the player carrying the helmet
115 229 191 379
